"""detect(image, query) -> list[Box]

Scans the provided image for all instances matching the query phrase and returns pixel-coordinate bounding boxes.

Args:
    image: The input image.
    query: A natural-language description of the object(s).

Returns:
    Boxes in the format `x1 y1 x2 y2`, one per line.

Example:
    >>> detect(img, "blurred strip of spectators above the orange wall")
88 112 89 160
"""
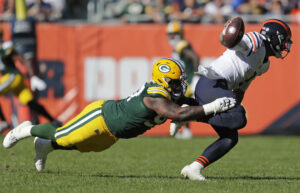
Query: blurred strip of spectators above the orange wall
0 0 300 23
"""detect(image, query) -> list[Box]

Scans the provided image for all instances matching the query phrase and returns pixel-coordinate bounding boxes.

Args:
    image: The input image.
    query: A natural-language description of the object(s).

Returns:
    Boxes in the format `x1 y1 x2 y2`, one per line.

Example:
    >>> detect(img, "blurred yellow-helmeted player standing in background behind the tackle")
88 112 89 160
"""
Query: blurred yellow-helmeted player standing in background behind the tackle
166 21 199 139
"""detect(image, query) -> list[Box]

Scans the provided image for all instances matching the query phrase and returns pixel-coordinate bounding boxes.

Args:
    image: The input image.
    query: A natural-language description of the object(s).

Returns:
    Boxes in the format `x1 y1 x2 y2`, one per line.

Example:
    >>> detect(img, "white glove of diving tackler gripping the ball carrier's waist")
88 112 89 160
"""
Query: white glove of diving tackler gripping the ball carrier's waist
203 97 236 115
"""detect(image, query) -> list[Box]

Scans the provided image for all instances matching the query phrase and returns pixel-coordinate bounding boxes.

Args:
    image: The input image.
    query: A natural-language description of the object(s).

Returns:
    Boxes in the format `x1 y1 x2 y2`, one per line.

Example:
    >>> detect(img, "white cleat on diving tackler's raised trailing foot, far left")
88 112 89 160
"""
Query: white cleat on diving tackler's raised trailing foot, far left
3 121 32 148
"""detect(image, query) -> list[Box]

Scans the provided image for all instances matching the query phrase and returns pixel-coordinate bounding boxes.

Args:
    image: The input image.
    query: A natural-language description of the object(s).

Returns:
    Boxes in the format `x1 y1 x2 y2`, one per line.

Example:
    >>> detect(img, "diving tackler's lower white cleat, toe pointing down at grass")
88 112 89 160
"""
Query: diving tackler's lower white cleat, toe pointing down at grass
34 137 53 172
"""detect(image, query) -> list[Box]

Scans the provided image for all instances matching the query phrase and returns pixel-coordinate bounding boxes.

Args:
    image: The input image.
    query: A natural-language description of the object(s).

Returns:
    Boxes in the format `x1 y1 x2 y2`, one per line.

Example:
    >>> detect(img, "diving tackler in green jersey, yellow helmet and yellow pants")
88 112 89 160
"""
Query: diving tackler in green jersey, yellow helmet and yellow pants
3 58 236 171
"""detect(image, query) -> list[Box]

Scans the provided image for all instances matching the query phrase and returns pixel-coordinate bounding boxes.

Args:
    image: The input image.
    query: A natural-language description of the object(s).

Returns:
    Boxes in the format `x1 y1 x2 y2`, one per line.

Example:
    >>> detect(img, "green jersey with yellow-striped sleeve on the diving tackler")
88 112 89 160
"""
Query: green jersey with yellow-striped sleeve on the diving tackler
102 82 171 138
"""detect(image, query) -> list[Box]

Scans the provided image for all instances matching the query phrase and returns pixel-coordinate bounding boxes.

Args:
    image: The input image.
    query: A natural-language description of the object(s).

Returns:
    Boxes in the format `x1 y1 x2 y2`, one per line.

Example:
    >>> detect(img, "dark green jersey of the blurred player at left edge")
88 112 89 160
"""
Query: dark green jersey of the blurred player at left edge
0 41 19 74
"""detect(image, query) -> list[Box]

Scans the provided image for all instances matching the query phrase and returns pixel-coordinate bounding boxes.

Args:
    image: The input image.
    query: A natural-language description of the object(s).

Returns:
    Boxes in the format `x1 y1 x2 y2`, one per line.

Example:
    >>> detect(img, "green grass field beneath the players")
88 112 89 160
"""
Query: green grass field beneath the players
0 136 300 193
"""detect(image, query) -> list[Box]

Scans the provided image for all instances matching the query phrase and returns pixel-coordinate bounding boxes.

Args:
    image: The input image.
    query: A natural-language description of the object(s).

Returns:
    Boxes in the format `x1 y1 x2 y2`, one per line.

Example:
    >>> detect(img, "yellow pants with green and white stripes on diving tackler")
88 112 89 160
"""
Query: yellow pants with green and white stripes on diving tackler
55 100 118 152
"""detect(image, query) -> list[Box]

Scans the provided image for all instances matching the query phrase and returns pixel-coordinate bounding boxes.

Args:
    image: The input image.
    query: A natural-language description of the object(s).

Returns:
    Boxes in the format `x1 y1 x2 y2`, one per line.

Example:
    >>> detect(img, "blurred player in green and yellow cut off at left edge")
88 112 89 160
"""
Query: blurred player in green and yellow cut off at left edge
0 26 60 128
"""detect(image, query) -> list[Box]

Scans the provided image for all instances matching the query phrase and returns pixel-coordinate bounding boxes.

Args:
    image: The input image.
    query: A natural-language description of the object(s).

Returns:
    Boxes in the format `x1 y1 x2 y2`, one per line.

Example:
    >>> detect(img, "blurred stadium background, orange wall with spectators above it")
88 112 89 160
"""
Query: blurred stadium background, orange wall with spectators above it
0 0 300 136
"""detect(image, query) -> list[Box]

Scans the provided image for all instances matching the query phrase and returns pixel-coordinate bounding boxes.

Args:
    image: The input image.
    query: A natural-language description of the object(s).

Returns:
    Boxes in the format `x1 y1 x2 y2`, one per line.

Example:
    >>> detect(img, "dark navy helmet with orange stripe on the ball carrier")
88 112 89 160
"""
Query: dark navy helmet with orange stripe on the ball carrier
260 19 293 59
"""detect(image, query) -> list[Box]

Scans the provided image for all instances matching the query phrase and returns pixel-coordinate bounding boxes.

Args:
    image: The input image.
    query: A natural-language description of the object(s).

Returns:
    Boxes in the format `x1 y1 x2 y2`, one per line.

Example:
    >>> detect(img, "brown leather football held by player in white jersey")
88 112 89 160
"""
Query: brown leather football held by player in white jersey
220 17 245 48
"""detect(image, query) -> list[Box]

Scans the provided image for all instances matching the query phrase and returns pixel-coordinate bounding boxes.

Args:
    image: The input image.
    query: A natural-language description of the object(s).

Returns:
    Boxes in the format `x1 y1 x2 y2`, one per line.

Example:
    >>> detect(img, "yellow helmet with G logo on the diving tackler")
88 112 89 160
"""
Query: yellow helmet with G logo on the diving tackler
152 58 187 97
